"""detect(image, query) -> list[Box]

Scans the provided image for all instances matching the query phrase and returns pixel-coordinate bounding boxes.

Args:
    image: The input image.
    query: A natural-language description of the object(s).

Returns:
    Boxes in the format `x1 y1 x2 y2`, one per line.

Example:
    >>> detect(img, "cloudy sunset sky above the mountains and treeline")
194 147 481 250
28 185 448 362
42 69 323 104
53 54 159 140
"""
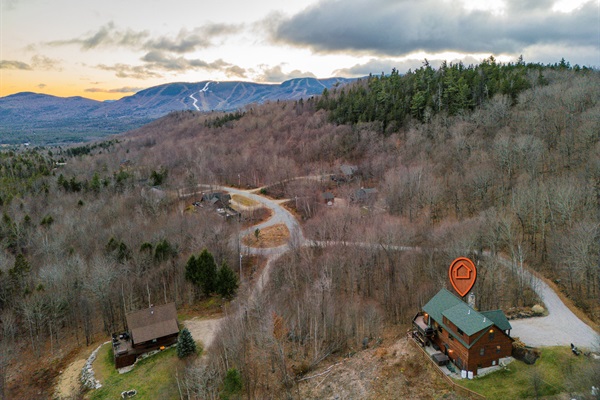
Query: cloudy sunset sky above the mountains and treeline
0 0 600 100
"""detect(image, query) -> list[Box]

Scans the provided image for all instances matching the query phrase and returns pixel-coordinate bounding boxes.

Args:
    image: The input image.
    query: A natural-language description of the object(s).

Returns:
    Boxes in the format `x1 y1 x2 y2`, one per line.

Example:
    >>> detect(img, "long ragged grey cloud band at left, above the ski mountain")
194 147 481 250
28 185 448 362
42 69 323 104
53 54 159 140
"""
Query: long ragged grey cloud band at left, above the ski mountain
47 22 242 54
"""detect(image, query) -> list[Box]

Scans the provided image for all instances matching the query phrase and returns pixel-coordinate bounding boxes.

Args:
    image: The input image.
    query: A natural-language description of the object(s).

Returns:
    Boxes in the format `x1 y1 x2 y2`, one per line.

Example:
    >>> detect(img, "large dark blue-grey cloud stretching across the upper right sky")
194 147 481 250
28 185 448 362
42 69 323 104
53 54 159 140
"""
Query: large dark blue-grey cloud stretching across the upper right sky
271 0 598 56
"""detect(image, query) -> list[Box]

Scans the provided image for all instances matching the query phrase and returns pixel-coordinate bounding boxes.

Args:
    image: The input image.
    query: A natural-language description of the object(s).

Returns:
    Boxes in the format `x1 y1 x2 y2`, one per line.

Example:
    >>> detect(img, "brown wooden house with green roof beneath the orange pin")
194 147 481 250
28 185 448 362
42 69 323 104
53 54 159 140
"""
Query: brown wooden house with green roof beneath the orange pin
413 289 513 375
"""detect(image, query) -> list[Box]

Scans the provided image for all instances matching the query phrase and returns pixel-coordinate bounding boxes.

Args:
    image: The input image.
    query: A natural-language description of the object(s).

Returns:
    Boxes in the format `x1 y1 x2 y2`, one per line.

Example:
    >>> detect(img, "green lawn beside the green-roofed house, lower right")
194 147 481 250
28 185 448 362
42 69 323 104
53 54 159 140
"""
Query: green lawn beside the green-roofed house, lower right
456 347 594 399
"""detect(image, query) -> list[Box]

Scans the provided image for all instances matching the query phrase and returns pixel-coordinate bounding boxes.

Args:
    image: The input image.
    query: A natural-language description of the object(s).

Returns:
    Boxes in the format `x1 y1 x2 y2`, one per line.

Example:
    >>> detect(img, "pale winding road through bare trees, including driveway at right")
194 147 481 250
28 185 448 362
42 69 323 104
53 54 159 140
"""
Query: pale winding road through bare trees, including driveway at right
185 185 600 351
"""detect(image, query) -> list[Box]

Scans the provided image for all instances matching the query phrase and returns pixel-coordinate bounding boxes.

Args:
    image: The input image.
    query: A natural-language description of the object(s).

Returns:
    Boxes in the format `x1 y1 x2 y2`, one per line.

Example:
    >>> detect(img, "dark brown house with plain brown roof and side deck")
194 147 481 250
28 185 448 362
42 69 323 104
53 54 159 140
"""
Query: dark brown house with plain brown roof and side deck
112 303 179 368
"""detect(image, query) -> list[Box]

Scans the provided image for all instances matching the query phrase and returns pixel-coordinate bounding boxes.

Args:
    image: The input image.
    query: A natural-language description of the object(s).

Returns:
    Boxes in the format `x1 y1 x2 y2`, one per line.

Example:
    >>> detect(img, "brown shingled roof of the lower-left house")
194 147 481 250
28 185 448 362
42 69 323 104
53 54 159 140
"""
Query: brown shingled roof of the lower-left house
126 303 179 343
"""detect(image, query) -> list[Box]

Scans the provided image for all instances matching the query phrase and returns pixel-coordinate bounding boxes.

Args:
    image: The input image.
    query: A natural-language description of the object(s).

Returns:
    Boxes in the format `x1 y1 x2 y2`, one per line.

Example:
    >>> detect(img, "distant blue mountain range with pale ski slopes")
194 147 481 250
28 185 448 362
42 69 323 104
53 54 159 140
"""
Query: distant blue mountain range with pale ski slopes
0 78 353 145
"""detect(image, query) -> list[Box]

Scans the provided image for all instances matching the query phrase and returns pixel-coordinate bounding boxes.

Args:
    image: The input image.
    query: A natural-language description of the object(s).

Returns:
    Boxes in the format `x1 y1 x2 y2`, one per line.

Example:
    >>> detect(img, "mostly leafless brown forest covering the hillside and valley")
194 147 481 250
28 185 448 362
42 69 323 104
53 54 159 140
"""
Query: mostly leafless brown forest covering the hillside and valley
0 57 600 398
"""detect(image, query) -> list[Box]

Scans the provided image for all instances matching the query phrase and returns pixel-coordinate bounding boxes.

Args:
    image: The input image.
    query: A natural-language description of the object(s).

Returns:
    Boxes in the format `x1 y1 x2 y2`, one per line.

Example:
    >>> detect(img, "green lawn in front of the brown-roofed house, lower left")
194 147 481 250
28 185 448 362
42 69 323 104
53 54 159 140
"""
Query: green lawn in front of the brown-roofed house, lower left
85 345 185 400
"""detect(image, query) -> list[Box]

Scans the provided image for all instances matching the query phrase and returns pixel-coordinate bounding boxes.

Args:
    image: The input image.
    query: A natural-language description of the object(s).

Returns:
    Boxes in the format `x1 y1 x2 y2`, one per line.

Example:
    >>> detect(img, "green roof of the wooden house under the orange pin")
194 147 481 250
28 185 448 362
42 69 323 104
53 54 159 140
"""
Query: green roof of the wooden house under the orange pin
423 289 512 348
